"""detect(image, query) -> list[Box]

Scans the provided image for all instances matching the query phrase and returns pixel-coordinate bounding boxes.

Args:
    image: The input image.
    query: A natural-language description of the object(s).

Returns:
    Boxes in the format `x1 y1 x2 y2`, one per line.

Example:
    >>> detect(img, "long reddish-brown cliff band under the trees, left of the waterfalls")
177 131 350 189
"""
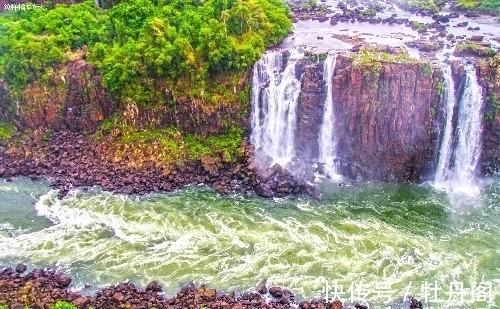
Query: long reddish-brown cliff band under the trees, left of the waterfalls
0 59 248 135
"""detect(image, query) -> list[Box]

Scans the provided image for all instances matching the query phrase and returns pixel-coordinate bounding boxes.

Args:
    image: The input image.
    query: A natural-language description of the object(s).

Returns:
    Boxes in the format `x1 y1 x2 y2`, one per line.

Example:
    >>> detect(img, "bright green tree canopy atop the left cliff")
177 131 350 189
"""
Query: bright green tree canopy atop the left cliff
0 0 292 105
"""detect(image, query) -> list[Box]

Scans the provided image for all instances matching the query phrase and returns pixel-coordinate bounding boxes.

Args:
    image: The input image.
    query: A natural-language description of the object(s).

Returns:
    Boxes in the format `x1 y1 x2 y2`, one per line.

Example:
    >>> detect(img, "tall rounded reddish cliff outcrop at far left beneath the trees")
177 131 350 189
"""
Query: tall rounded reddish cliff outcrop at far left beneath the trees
10 60 116 132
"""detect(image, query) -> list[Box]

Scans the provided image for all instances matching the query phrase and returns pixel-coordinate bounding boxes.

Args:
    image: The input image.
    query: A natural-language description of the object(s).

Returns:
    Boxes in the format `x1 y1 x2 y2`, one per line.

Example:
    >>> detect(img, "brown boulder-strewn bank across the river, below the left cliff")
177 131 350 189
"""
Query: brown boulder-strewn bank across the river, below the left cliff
0 131 316 198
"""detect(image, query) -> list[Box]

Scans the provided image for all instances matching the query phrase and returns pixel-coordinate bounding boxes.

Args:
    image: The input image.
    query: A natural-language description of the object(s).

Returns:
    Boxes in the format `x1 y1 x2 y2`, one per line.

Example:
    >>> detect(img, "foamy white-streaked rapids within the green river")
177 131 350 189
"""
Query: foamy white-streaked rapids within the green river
0 183 496 304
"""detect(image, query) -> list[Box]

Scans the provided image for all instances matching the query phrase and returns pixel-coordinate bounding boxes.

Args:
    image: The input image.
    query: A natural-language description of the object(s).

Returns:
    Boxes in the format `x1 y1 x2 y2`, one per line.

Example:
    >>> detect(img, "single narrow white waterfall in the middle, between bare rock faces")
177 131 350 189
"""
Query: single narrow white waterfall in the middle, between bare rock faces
318 53 340 178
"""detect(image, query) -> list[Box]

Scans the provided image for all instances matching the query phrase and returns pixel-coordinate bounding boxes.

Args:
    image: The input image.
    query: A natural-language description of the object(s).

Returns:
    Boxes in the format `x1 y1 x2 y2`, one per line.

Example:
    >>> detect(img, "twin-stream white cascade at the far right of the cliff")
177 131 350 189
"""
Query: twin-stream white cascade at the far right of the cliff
435 66 483 192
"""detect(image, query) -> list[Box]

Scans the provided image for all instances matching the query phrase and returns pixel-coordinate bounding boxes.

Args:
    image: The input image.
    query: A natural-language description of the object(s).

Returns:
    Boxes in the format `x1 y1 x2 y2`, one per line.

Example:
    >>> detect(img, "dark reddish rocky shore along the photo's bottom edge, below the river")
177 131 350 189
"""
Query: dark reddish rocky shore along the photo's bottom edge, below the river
0 264 423 309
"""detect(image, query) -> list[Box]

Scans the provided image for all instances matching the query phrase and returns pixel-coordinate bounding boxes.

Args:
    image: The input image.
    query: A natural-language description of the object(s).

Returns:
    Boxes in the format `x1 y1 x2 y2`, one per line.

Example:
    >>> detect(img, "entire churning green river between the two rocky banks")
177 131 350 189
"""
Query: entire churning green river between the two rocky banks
0 179 500 308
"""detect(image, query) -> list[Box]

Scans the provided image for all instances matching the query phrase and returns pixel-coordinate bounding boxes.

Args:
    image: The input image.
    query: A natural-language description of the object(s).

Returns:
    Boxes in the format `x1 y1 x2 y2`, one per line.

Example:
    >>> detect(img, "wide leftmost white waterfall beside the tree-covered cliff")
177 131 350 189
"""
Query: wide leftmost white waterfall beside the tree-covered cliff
250 49 303 166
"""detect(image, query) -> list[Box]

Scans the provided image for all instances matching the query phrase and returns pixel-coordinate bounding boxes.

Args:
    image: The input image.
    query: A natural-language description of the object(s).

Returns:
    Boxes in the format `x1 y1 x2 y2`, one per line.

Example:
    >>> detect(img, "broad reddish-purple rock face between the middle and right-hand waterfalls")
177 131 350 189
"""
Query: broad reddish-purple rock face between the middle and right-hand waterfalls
326 55 441 181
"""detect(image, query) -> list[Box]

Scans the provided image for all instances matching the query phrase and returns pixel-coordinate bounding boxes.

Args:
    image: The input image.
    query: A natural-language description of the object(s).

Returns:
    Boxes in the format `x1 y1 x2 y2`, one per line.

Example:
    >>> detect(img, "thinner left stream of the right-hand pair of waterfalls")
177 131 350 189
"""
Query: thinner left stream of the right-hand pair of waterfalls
434 65 457 183
